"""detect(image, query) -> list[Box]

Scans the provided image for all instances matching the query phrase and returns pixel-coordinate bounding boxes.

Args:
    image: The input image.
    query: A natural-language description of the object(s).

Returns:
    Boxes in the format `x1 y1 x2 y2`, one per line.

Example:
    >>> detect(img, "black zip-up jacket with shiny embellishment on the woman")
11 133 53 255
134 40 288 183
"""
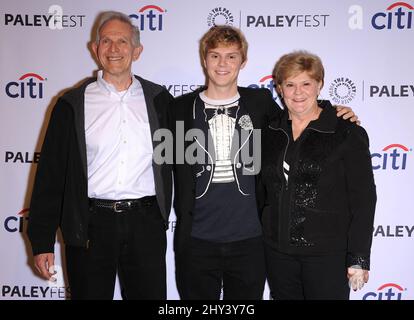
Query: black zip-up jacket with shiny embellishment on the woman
256 102 376 269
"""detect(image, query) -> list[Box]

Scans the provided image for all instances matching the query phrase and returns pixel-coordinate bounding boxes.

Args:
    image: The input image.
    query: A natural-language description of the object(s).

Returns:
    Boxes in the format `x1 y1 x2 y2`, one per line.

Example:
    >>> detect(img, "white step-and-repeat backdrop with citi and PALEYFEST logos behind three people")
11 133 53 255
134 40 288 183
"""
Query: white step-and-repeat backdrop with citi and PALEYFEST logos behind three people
0 0 414 300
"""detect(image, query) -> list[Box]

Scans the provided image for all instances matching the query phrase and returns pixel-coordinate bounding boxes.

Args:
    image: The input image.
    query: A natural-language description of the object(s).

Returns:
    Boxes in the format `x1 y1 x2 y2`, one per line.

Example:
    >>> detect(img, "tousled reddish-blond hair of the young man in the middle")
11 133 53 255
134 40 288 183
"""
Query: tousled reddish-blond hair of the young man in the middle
200 25 248 62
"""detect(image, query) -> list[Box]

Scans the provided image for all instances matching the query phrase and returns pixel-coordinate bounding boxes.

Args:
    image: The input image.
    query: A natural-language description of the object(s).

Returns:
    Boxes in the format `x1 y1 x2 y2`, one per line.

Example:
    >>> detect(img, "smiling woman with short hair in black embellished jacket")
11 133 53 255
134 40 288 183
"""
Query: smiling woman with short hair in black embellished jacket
257 51 376 299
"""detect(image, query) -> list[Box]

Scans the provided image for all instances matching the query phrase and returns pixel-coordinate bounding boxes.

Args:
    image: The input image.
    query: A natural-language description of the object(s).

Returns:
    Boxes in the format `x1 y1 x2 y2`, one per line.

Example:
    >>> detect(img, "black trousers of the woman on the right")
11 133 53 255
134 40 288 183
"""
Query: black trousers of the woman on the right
265 245 349 300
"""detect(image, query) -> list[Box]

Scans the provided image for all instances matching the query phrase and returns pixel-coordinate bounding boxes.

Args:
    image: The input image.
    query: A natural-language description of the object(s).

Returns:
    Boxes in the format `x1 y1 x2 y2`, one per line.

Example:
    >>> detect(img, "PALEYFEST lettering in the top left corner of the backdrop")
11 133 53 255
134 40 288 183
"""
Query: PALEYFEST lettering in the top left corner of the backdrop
3 4 86 30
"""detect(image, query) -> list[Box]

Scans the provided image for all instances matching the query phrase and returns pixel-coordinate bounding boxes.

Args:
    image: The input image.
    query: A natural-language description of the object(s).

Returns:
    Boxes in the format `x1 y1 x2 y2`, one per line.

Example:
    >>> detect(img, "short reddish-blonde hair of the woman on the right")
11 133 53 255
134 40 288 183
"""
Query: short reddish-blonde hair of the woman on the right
272 50 325 94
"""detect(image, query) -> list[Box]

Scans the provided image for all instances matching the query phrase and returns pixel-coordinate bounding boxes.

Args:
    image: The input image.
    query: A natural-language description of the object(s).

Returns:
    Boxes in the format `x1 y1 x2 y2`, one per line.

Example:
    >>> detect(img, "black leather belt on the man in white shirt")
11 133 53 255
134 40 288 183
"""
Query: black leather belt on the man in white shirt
89 196 157 213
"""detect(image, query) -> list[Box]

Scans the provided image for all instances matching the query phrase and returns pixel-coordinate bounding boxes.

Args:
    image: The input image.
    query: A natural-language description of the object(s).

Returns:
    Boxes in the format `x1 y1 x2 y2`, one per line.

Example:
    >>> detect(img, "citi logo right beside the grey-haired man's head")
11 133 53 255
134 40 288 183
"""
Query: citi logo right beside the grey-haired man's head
129 5 167 31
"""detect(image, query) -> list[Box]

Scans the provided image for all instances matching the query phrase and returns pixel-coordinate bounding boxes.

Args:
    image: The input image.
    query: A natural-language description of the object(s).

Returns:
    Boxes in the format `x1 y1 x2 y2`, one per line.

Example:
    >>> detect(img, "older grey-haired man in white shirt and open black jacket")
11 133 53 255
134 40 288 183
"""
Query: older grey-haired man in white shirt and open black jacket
28 11 172 299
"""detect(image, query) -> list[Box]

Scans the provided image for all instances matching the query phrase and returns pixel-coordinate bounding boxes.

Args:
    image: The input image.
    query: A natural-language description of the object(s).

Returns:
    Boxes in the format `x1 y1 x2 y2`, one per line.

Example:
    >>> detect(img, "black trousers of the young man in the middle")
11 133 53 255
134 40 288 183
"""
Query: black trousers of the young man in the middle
176 237 266 300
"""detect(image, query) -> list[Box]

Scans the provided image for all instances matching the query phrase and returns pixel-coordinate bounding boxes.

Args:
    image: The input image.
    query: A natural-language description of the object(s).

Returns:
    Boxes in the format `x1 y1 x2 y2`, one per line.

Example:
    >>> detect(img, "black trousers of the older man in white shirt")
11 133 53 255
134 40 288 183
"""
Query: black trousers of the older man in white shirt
66 203 167 300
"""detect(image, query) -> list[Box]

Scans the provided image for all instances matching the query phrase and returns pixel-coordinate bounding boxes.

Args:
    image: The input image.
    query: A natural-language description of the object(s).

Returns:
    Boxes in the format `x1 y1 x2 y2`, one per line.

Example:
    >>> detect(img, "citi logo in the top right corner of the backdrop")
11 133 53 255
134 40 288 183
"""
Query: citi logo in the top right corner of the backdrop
371 2 414 30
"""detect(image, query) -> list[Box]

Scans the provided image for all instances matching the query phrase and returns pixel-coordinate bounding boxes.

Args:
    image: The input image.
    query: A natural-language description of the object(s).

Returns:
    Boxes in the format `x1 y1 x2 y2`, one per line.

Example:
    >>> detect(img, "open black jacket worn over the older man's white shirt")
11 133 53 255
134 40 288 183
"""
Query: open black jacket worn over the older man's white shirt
27 76 172 255
